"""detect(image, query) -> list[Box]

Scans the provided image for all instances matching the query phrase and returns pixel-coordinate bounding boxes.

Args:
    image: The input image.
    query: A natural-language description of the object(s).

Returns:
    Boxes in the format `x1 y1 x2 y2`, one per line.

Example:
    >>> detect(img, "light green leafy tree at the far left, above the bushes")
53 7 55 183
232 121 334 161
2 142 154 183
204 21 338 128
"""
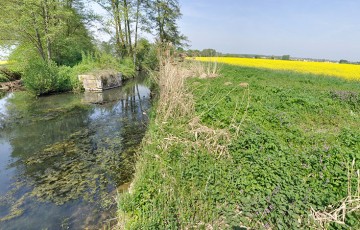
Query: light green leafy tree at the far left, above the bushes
0 0 92 65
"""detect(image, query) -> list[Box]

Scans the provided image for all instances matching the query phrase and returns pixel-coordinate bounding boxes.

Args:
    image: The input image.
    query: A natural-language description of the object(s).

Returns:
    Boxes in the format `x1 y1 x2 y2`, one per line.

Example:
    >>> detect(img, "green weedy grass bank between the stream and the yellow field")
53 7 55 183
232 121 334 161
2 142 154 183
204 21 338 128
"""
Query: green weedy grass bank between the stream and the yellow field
119 64 360 229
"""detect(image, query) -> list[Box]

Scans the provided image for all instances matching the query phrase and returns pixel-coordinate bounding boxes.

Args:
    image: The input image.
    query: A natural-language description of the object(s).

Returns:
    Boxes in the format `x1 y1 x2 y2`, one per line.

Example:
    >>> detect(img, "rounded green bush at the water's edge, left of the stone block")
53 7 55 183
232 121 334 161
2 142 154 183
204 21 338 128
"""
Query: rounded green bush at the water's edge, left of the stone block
23 59 72 95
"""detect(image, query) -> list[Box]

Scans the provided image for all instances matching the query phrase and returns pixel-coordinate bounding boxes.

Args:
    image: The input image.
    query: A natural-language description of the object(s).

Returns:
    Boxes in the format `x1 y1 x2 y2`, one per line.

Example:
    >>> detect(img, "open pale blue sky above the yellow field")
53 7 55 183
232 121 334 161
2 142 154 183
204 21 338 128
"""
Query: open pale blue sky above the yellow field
179 0 360 61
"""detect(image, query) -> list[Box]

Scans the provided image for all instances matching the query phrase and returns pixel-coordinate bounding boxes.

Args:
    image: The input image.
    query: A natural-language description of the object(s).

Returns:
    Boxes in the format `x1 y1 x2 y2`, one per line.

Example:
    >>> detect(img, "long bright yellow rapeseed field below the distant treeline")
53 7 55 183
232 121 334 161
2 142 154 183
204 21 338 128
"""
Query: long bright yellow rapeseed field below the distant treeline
193 57 360 80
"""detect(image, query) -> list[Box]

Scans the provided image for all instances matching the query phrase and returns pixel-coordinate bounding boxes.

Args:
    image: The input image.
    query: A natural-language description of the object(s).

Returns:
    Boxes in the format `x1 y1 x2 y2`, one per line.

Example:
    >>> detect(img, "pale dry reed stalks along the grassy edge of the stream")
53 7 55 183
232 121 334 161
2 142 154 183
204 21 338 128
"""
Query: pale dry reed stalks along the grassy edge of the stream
157 44 250 157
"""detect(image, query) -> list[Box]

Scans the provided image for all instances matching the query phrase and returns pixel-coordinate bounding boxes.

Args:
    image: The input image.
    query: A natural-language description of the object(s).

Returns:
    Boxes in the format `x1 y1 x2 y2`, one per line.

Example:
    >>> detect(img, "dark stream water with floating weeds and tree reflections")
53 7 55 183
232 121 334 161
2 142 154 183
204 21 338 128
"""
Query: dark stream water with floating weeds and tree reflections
0 75 150 229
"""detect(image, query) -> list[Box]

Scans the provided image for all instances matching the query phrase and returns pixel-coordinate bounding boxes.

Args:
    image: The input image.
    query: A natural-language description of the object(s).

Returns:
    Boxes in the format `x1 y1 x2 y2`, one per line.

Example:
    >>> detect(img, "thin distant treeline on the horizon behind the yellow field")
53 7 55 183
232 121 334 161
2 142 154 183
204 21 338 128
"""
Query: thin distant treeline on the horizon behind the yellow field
185 49 360 65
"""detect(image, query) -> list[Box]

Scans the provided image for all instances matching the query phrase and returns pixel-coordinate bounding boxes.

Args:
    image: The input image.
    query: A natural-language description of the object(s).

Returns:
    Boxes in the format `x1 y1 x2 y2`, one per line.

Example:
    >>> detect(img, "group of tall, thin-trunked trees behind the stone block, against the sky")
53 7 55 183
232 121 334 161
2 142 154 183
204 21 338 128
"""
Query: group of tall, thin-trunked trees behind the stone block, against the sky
95 0 185 64
